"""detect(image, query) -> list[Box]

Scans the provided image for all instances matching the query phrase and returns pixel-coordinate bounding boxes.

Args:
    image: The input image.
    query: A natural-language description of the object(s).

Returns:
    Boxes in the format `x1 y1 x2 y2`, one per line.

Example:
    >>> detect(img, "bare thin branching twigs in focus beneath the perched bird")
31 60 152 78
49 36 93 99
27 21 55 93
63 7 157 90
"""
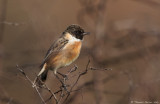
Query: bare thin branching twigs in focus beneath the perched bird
17 60 109 104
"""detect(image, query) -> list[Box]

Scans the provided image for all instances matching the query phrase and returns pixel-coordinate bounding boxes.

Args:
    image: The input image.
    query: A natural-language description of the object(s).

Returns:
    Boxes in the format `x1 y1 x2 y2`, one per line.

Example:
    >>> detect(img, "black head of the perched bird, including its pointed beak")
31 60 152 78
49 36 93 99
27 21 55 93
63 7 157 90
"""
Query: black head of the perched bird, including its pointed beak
65 25 89 40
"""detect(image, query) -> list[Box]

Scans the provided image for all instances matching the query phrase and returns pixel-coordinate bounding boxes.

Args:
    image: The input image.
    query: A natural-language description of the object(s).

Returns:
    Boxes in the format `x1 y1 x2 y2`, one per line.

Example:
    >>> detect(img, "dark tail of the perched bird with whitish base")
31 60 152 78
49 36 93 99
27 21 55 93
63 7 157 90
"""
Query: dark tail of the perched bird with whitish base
36 64 48 86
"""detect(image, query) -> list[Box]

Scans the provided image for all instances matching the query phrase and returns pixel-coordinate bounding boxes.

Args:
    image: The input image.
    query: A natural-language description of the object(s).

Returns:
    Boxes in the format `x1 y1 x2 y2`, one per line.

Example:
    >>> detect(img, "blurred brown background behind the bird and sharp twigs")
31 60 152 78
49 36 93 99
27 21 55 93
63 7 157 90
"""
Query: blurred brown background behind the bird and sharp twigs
0 0 160 104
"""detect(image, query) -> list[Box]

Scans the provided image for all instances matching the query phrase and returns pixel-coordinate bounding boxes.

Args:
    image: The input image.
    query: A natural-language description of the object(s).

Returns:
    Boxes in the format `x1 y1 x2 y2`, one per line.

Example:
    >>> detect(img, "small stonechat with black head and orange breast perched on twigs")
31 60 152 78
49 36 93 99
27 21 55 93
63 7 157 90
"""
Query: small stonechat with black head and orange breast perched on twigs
38 25 89 82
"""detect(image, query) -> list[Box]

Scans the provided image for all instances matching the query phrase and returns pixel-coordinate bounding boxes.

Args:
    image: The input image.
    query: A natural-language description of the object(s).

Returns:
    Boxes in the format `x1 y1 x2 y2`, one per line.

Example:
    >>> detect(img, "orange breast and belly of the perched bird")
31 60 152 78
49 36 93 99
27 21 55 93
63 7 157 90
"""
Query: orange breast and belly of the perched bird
48 41 82 68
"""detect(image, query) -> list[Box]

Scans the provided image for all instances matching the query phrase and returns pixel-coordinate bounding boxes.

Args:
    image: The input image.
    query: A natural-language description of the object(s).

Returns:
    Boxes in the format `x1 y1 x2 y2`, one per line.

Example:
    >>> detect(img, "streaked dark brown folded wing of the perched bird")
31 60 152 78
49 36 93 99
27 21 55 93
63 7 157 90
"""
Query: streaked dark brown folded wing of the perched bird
40 36 68 68
